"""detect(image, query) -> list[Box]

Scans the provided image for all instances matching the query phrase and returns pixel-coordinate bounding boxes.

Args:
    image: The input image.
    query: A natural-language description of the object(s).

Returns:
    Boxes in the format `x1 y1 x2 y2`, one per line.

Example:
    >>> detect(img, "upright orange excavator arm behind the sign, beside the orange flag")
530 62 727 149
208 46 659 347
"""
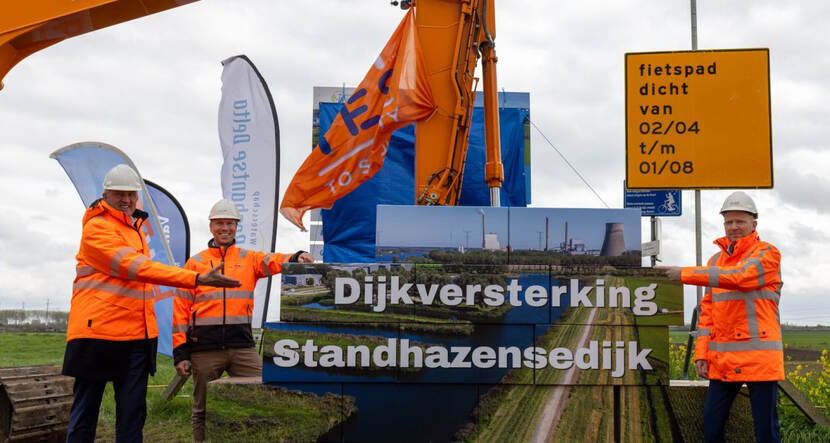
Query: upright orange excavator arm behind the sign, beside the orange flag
402 0 504 206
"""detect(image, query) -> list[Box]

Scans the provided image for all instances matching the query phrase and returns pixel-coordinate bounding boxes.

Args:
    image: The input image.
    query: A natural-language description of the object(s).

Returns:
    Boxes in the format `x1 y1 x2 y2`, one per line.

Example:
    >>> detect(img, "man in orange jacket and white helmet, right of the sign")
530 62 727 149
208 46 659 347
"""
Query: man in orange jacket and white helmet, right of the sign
658 191 784 442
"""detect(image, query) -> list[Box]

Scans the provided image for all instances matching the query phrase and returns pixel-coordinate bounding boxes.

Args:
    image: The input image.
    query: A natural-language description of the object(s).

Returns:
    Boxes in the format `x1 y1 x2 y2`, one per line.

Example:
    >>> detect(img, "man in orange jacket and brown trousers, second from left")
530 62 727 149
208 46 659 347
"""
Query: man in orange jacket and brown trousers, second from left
173 199 314 442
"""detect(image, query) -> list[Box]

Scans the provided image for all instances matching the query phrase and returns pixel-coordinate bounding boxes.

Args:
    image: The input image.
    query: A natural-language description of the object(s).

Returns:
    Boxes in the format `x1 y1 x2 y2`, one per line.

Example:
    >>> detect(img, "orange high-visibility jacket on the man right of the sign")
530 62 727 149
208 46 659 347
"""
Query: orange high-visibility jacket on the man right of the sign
681 231 784 381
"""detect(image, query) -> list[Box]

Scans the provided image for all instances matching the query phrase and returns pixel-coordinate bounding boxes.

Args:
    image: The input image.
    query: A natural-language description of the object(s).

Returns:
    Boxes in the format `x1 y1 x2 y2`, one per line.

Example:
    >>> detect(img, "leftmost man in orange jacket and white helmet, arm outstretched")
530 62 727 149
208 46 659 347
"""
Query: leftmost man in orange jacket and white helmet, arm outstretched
63 164 239 442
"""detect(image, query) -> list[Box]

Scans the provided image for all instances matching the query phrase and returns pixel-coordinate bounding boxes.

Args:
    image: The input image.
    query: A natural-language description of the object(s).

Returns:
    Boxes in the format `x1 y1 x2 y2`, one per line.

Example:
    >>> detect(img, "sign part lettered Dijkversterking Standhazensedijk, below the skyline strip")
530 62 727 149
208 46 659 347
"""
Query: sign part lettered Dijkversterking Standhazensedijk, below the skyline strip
263 262 683 441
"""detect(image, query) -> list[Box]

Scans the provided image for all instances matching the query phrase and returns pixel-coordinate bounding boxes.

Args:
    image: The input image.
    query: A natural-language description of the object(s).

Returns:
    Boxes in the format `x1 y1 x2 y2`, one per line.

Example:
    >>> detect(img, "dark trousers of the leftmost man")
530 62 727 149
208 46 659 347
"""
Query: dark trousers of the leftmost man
66 345 149 443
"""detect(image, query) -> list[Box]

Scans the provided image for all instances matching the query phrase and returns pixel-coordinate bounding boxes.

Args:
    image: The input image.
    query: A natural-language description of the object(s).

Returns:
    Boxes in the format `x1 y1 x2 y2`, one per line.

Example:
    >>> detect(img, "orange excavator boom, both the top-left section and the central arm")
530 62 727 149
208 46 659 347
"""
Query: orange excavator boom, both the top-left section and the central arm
0 0 504 206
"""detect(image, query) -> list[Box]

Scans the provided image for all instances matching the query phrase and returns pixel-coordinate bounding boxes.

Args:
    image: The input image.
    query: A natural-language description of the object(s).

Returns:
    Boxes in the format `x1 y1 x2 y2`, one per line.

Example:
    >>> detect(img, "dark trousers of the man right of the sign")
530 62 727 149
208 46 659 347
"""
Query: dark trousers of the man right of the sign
703 380 781 443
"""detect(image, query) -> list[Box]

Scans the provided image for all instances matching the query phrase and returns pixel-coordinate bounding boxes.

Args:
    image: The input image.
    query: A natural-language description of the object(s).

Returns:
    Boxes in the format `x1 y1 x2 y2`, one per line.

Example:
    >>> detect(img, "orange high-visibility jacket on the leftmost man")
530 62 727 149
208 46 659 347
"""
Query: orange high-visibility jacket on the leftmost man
66 200 198 342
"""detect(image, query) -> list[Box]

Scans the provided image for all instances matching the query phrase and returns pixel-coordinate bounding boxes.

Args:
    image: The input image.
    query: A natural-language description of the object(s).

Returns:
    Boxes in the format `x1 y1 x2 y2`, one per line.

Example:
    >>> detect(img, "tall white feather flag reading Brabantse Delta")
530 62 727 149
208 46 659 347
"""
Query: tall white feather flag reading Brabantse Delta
219 55 280 328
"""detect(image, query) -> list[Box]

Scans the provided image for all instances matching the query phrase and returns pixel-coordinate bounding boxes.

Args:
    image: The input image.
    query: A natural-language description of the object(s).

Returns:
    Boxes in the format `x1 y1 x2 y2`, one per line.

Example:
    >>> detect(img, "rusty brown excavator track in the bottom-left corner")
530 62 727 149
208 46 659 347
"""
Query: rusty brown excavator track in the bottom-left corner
0 366 74 442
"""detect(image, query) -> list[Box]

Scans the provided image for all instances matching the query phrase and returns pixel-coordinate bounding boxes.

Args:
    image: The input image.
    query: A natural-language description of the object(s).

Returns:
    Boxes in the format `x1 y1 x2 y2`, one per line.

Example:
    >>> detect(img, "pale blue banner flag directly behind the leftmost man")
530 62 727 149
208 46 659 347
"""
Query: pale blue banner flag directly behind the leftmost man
49 142 182 356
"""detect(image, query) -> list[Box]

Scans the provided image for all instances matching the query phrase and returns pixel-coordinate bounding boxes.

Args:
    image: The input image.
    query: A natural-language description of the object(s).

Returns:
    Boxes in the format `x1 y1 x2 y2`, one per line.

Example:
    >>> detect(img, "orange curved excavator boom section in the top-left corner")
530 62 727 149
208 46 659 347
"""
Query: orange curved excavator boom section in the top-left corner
0 0 196 89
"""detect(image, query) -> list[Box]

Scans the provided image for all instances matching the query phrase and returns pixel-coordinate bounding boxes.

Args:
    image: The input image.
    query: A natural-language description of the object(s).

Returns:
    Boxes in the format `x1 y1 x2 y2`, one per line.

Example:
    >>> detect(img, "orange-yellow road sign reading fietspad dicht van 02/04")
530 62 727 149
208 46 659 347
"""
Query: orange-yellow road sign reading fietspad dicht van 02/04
625 48 773 189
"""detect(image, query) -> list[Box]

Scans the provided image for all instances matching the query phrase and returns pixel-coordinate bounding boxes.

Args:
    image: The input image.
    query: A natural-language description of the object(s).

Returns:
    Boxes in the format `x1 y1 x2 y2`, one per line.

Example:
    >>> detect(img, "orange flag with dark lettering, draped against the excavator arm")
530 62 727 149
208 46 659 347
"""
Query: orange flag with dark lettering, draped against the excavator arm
280 9 436 231
